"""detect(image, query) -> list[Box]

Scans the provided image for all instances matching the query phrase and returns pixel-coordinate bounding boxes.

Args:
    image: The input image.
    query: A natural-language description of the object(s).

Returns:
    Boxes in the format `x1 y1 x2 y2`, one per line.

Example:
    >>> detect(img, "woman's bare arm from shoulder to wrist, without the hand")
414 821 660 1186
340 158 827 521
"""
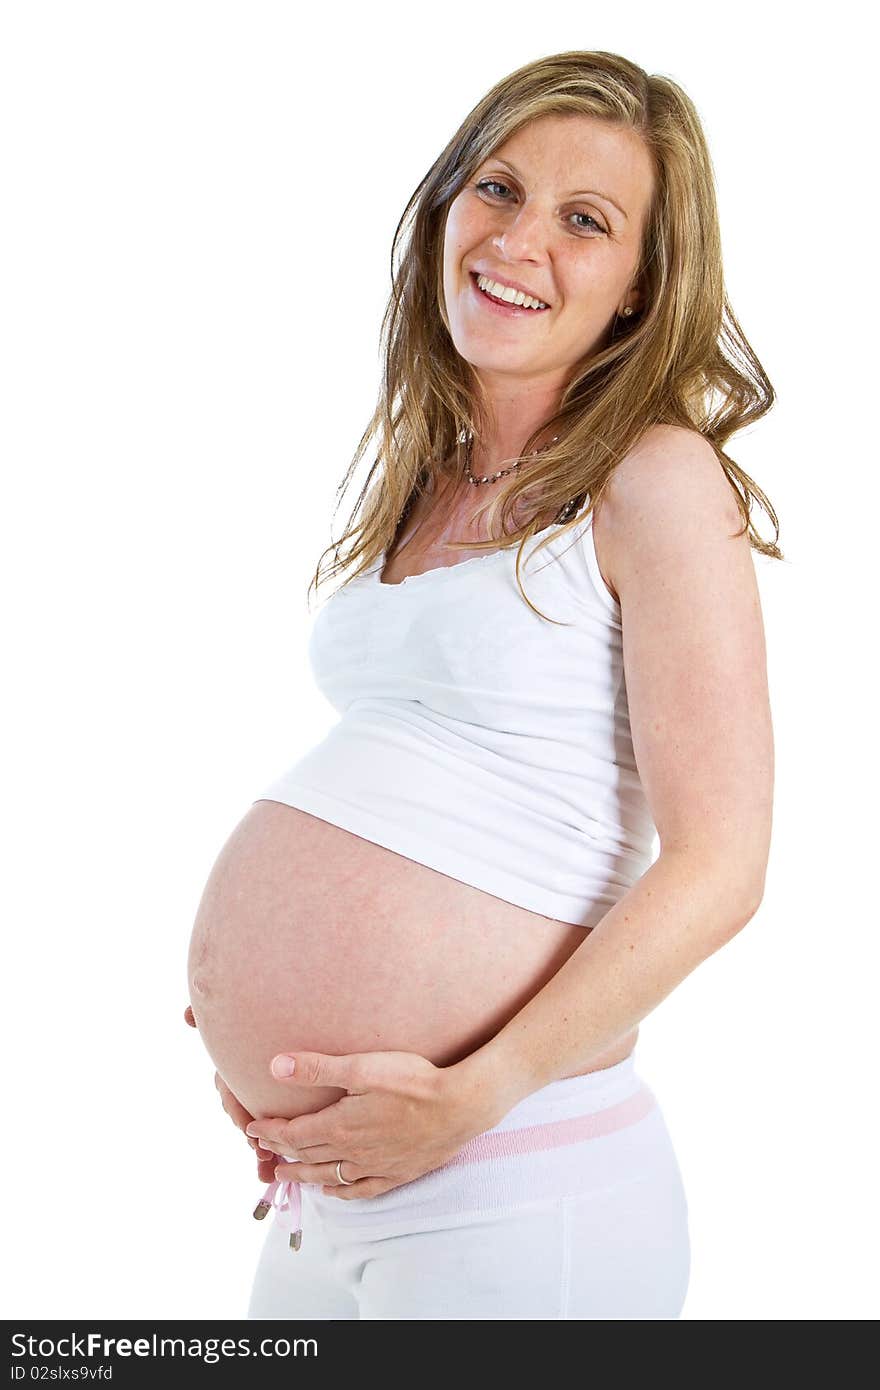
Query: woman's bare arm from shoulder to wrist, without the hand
452 427 773 1119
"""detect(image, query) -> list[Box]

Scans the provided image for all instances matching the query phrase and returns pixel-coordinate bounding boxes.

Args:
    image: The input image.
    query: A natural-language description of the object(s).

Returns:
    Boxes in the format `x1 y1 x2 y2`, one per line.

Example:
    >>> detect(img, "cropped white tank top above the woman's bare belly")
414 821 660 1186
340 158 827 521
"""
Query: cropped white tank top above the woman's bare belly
254 516 656 926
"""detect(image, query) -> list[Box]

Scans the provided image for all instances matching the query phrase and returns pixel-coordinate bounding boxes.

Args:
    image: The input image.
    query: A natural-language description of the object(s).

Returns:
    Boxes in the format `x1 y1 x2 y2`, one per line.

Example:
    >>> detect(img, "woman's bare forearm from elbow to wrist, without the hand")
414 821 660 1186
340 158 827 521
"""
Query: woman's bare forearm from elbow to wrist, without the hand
453 853 759 1125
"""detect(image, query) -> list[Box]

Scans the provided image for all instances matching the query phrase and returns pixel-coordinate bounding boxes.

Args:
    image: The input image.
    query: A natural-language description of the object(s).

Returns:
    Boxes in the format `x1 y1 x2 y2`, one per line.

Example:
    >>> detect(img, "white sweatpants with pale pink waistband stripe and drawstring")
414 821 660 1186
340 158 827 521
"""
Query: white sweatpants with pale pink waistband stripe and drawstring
247 1054 690 1321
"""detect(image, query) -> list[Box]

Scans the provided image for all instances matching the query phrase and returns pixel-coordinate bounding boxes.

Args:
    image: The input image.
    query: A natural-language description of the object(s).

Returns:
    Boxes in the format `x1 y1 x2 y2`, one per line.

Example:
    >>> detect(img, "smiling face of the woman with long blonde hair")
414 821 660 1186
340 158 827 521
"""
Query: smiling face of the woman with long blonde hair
443 115 653 389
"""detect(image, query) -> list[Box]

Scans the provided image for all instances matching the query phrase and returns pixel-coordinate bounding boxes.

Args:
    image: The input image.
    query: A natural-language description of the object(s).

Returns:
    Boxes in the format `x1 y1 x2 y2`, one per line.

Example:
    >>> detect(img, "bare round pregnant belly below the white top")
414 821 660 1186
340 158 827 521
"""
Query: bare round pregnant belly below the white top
188 801 638 1118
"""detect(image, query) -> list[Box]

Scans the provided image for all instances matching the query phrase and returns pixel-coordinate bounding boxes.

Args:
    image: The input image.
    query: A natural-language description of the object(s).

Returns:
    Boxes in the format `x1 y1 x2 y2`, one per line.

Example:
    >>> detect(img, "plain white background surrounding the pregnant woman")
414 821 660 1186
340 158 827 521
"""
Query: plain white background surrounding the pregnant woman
0 0 879 1321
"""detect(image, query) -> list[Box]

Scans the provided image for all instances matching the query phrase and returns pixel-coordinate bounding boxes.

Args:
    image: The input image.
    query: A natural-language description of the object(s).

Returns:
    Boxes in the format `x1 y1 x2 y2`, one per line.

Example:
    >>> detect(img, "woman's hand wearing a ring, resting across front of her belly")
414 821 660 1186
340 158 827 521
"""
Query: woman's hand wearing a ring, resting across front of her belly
246 1052 495 1198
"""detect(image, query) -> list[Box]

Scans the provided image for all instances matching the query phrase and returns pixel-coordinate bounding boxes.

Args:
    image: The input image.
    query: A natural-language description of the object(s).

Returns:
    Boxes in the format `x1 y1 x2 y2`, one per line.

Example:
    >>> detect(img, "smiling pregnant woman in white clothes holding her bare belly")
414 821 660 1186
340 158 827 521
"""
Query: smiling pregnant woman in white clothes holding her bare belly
186 51 781 1319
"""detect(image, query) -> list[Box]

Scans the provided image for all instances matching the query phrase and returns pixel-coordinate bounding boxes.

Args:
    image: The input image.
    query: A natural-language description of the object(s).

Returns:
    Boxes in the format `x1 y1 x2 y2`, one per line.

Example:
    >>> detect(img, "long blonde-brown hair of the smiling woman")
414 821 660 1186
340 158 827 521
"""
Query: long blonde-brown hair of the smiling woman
309 51 783 617
